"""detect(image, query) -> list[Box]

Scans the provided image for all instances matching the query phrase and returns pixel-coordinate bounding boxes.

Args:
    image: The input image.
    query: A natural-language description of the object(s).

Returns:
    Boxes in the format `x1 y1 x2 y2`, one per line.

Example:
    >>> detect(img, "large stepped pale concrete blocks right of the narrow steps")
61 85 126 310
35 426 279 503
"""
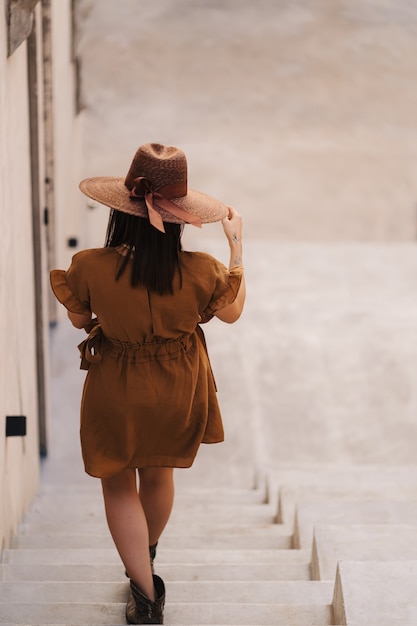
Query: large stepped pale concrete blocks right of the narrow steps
270 465 417 626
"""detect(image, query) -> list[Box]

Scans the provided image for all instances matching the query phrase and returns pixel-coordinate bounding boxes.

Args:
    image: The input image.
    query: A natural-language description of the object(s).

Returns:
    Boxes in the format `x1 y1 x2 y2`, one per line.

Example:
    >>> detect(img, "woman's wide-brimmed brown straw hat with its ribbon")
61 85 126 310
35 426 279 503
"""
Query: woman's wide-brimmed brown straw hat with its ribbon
80 143 229 231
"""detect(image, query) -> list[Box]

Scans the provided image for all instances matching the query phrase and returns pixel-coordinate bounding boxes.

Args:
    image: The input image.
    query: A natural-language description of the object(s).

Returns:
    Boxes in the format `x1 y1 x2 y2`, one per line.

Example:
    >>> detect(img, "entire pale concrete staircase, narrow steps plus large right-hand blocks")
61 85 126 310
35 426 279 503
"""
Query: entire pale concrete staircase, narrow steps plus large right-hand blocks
0 466 417 626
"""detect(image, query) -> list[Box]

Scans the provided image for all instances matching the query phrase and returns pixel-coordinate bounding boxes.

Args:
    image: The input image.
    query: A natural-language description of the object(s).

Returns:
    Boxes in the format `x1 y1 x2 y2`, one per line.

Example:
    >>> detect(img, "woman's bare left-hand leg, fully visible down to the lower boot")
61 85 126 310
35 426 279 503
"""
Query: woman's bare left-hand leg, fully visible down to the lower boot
101 469 155 601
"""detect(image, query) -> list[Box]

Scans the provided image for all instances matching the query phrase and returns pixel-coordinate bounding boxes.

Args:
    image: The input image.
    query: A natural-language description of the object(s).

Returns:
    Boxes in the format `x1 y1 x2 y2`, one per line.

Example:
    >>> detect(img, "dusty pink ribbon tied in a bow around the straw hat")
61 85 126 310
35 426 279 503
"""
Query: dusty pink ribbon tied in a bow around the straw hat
130 176 201 233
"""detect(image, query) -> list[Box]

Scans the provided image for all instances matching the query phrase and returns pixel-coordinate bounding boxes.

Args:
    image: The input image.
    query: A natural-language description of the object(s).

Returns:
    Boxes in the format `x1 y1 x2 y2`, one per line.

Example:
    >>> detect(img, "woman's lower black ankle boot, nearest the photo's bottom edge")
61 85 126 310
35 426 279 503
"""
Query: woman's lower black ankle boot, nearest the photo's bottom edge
126 574 165 624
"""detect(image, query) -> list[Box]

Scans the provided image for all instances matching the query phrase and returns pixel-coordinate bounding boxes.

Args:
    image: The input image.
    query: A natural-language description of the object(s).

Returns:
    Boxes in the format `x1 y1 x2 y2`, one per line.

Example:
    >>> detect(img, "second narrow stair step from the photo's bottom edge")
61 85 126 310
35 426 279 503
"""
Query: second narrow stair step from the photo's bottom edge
0 579 334 605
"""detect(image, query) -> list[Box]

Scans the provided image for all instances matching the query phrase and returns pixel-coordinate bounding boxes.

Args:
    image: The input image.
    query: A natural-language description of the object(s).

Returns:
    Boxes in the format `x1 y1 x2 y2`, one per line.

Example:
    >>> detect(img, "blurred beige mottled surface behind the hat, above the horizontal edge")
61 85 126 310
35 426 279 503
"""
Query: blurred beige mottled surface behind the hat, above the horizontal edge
76 0 417 241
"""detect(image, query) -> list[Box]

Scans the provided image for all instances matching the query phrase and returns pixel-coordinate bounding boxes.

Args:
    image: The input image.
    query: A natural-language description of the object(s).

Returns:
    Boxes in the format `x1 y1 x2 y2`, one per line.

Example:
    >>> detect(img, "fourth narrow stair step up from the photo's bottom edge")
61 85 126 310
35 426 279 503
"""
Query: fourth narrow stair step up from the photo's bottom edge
3 548 311 567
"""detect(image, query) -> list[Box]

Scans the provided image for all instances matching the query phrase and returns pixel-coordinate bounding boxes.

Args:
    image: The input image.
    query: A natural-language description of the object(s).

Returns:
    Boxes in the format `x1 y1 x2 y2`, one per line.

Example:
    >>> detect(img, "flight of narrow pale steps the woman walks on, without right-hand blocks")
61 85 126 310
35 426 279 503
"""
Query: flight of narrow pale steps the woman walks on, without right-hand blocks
0 472 334 626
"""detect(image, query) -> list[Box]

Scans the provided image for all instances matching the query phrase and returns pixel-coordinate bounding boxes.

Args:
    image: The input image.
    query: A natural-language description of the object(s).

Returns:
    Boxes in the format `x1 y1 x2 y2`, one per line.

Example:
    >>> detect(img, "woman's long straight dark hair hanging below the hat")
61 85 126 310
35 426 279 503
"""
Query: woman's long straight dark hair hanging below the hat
105 209 183 295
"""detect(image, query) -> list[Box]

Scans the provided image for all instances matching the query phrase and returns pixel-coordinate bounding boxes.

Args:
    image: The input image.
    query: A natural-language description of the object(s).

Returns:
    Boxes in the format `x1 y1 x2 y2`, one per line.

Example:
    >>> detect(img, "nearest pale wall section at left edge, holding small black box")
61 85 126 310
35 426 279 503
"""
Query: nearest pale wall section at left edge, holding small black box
0 2 39 544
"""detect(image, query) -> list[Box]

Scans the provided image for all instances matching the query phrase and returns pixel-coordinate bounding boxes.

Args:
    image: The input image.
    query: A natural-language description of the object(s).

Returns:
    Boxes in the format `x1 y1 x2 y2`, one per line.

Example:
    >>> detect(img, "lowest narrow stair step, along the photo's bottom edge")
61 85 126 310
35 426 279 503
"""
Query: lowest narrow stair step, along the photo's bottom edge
0 602 333 626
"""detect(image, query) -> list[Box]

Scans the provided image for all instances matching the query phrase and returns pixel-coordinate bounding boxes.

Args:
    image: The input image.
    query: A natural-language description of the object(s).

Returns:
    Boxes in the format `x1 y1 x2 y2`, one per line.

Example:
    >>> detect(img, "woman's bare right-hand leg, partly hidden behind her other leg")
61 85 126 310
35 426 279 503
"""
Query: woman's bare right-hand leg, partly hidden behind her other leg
139 467 174 546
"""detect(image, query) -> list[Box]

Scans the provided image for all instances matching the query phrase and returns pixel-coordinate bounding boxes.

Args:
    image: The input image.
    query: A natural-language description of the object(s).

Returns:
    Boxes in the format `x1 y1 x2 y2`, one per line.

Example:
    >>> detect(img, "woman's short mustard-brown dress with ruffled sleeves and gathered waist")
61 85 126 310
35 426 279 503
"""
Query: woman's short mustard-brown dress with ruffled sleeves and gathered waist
51 248 243 478
